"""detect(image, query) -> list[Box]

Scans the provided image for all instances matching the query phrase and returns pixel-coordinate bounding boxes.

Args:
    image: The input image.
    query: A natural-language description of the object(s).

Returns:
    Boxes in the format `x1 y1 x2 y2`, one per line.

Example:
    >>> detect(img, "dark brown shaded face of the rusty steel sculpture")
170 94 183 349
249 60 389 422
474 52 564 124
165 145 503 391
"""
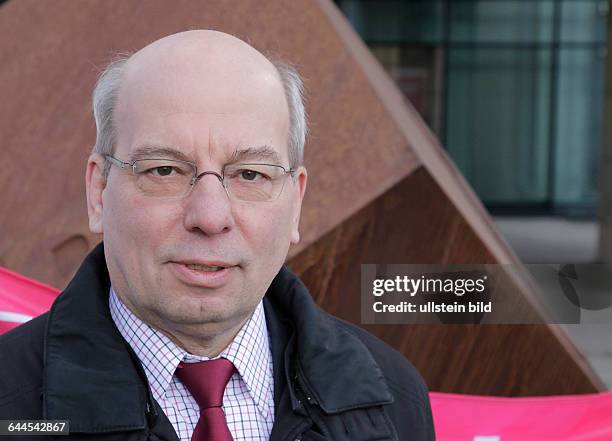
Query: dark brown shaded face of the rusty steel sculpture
290 168 603 396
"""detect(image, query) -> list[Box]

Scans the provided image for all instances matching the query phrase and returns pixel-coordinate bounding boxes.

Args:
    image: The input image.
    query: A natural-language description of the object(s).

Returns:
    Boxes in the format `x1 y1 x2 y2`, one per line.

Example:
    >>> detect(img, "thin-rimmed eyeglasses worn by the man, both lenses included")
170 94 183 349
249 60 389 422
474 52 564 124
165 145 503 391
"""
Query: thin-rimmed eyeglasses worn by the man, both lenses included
105 155 296 202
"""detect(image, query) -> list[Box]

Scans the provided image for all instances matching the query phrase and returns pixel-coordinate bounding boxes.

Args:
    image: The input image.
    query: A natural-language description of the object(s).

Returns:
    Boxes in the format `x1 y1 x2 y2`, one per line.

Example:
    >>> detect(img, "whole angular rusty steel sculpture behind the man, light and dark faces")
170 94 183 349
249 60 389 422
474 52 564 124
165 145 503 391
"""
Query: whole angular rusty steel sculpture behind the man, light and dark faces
0 0 602 395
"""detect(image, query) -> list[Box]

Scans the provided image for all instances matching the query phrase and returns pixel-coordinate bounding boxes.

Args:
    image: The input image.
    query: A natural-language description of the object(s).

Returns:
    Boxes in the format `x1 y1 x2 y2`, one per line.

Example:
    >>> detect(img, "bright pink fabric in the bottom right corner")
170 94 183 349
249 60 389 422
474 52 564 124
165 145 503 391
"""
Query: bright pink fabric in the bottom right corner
430 392 612 441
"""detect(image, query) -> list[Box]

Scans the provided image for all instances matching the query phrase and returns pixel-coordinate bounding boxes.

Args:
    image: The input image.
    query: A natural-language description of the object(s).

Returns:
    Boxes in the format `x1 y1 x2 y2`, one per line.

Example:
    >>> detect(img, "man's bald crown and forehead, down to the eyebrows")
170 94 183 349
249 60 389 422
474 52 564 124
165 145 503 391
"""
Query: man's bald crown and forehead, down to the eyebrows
115 31 289 163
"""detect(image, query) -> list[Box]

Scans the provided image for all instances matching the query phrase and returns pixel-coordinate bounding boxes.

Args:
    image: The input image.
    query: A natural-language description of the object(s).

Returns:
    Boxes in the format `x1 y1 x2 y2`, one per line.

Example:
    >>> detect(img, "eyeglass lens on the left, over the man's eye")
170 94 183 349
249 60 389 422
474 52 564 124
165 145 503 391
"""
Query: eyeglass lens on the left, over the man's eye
134 159 195 197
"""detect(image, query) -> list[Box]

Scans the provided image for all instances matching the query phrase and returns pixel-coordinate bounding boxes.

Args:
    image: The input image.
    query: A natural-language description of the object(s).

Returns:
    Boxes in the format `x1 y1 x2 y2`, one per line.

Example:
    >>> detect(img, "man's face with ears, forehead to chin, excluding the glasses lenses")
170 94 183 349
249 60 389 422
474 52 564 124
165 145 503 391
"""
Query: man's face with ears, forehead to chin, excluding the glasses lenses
88 35 306 344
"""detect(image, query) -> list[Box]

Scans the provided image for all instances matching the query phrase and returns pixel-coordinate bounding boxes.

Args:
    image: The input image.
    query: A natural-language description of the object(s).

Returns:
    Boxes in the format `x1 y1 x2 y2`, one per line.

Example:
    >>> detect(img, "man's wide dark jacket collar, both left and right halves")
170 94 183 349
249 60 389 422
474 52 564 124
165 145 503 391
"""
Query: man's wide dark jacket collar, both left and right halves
43 244 393 432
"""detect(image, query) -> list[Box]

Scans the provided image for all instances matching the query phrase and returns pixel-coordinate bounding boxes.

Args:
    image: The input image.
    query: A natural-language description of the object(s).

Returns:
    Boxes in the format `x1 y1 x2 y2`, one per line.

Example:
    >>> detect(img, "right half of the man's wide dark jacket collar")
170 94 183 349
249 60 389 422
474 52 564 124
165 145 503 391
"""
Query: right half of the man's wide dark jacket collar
266 267 393 414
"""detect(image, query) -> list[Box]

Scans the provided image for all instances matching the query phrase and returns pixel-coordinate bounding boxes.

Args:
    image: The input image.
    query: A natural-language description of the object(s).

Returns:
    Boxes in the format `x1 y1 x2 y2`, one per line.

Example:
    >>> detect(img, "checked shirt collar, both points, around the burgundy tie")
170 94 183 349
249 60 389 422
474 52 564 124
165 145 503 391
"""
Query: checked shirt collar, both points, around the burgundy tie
109 287 273 415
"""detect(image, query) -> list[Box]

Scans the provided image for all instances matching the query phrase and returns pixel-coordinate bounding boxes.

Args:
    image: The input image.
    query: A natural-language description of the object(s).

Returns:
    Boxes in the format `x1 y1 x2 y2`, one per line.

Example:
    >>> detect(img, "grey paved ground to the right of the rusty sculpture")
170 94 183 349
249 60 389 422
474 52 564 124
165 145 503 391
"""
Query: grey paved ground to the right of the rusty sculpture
494 217 612 390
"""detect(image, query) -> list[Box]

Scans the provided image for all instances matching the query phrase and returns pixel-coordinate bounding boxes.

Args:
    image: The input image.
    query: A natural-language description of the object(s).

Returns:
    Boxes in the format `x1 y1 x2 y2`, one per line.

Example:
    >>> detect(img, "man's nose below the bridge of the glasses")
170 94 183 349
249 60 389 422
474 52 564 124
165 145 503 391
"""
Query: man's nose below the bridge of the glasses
184 173 234 235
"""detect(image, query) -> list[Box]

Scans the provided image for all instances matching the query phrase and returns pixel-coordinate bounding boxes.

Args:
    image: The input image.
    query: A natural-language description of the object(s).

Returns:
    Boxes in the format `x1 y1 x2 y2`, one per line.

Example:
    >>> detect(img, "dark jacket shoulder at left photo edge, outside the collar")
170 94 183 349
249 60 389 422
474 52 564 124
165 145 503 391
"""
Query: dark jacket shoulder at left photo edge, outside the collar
0 314 48 419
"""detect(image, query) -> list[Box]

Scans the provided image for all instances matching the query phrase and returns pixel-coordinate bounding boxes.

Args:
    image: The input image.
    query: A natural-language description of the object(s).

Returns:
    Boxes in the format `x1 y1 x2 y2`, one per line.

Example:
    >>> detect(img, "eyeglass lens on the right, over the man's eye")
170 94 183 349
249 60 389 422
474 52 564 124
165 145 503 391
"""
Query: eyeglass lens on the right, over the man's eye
224 164 285 201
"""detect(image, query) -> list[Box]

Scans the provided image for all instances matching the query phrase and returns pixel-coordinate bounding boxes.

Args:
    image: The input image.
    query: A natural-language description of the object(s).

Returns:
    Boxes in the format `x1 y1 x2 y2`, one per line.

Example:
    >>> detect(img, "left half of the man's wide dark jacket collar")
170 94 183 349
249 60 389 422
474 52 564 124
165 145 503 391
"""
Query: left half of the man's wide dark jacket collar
43 244 150 432
